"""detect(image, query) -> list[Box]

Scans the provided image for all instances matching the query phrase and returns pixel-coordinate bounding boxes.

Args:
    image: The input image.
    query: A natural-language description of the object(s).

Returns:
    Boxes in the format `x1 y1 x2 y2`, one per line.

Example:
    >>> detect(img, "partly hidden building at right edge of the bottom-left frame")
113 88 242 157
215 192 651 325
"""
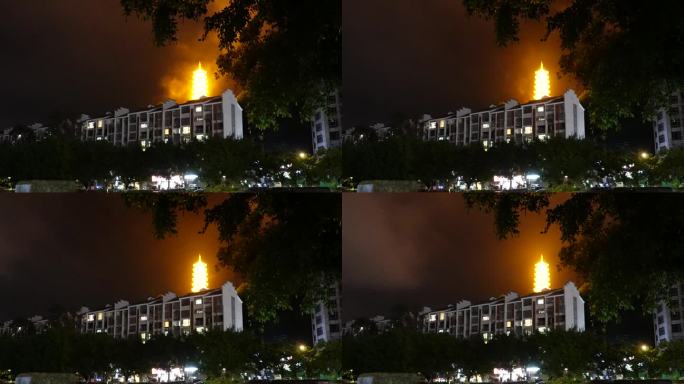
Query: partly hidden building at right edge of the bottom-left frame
311 284 342 345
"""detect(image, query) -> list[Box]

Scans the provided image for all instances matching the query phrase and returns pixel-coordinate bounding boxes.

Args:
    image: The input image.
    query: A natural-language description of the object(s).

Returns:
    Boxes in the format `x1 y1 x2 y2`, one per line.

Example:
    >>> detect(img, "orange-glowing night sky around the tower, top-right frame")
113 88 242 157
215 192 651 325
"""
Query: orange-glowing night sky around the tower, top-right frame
342 0 652 148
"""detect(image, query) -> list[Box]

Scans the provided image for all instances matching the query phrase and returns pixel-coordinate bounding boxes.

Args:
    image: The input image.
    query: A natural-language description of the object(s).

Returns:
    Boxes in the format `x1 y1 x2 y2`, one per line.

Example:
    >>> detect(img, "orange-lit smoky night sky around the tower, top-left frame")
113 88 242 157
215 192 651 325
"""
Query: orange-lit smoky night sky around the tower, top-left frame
0 0 234 127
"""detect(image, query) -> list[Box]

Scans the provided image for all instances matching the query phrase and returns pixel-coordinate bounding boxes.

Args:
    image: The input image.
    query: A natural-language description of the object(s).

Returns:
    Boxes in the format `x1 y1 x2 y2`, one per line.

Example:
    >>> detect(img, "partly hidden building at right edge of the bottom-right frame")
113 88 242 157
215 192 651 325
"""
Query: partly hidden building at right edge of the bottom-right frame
653 283 684 345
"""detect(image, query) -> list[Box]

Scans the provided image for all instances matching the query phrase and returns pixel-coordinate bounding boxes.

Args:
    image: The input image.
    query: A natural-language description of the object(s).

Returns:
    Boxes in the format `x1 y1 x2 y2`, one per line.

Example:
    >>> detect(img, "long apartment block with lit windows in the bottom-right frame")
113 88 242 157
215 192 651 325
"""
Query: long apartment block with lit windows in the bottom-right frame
421 282 585 341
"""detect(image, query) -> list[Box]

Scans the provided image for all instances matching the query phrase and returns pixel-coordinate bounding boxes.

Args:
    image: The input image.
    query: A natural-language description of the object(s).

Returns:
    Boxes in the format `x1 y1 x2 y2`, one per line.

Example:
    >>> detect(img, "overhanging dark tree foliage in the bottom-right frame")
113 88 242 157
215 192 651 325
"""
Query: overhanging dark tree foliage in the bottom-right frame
463 192 684 321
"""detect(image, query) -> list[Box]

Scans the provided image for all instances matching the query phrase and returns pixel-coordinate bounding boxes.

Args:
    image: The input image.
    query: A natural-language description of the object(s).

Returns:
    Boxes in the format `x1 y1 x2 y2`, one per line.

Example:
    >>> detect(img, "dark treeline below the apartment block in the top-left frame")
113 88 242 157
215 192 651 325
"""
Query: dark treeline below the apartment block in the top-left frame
0 135 341 190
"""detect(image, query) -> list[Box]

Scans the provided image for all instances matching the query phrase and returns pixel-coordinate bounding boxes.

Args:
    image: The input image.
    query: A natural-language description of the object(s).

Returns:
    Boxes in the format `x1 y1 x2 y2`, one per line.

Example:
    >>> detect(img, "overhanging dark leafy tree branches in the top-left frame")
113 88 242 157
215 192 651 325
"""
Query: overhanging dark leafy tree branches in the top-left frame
121 0 342 129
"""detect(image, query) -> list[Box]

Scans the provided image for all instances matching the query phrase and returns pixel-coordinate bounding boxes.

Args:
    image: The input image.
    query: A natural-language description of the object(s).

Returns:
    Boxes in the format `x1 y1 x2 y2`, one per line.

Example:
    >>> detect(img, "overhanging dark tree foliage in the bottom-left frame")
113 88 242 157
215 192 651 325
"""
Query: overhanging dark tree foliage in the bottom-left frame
122 191 342 324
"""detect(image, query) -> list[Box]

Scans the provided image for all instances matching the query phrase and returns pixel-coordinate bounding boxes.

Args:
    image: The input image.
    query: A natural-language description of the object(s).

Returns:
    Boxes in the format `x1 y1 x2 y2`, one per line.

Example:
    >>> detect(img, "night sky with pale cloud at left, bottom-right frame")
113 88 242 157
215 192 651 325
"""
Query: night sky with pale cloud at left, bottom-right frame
342 194 652 341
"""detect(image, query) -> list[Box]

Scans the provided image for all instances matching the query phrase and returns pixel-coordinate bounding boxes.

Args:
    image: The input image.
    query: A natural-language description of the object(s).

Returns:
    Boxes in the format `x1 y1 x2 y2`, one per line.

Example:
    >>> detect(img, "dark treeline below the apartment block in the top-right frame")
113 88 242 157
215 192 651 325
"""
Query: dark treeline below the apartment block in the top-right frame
342 135 684 191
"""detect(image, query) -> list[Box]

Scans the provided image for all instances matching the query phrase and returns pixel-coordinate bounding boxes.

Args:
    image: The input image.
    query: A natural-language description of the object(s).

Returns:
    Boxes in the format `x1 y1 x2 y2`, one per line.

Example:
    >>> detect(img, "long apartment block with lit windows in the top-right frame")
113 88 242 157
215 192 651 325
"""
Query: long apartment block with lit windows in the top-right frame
421 89 584 148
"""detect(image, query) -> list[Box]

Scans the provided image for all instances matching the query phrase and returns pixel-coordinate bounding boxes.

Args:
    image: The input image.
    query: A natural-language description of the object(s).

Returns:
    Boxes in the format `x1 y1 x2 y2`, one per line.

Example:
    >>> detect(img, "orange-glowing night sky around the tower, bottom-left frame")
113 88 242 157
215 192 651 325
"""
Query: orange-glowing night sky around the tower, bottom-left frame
0 193 310 340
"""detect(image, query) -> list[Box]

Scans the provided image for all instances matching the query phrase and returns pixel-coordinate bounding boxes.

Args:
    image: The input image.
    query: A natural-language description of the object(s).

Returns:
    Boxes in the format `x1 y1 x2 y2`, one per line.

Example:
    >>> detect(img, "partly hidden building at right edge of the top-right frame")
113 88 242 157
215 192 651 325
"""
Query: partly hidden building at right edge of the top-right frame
653 91 684 153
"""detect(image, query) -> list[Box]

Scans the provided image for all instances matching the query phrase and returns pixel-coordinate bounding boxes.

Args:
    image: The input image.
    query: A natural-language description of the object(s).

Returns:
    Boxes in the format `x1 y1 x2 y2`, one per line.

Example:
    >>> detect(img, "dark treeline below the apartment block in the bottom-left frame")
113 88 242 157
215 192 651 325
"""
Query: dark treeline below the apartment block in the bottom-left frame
0 327 341 381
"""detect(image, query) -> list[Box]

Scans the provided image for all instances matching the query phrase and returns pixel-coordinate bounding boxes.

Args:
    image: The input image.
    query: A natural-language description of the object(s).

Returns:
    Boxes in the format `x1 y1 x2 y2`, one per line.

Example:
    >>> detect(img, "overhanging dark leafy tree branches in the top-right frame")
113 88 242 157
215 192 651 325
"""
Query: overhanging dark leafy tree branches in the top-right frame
463 0 684 130
